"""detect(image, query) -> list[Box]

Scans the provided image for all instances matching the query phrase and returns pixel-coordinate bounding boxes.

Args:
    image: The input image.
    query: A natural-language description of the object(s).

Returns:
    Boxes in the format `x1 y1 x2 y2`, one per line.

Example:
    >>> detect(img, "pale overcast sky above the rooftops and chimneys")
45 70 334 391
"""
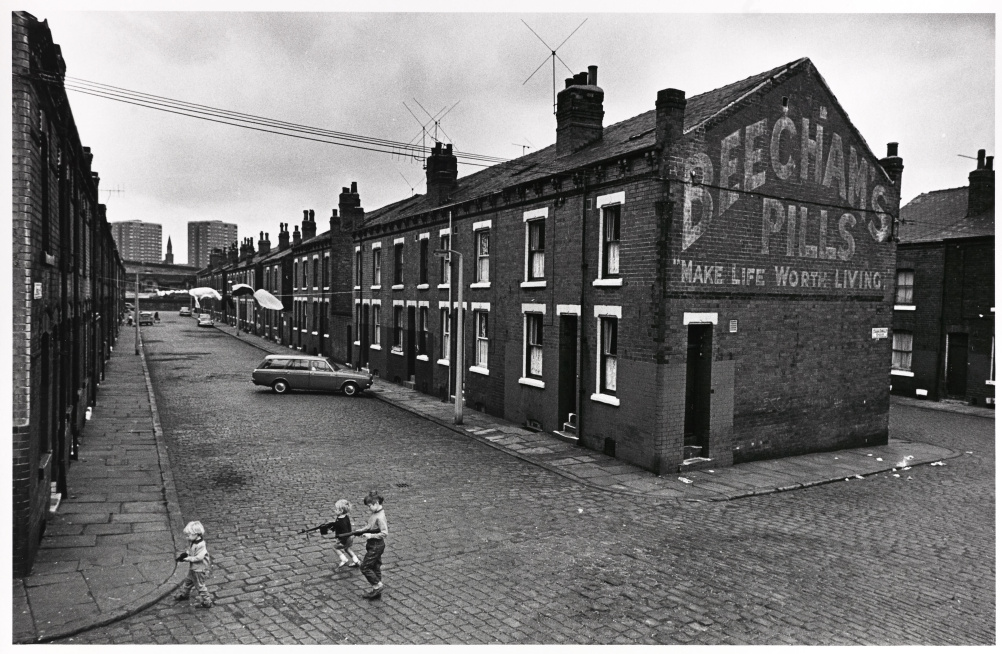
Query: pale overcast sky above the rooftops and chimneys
13 0 995 263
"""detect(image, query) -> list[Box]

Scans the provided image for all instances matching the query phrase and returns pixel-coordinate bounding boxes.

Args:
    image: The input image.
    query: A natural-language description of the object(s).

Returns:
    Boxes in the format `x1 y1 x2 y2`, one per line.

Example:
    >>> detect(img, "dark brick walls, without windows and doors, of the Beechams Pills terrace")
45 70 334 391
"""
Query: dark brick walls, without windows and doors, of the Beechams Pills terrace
348 61 901 472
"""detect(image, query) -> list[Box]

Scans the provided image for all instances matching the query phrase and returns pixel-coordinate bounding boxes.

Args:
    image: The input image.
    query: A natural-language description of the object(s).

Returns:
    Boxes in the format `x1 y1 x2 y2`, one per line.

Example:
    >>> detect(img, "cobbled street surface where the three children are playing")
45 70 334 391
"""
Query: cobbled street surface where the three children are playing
63 315 995 645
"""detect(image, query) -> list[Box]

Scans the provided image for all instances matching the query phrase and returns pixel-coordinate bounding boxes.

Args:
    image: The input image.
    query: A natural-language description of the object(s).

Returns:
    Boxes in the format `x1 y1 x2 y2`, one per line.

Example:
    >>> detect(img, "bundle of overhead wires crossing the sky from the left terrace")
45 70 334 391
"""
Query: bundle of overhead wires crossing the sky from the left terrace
23 73 508 166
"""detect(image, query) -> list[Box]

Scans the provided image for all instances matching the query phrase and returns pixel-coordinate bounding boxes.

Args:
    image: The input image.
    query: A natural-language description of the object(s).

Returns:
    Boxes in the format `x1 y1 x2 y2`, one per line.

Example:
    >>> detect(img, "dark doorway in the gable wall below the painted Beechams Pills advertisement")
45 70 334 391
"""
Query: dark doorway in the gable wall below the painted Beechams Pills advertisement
684 324 713 459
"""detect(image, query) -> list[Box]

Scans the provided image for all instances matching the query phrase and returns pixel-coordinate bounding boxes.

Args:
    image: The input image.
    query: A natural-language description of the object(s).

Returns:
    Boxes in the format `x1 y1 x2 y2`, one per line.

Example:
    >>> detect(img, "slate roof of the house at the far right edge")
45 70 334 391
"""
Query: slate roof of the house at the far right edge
898 186 995 243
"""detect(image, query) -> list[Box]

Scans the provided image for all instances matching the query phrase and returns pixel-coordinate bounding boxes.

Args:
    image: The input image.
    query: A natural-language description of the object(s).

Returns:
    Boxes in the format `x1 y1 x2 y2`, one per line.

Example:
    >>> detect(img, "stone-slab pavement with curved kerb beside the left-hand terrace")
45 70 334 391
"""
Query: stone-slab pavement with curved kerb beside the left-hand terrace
12 348 187 643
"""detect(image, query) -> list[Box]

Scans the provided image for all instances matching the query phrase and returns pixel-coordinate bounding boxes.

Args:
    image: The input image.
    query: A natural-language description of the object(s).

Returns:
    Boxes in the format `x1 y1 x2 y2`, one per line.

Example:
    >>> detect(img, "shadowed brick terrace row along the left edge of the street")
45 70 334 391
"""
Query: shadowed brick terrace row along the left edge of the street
9 11 125 577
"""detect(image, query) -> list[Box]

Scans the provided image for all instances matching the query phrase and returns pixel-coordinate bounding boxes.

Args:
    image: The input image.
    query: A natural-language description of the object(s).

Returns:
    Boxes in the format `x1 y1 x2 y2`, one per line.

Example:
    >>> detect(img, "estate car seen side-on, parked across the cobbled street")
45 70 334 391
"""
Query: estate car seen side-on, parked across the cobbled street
251 355 373 397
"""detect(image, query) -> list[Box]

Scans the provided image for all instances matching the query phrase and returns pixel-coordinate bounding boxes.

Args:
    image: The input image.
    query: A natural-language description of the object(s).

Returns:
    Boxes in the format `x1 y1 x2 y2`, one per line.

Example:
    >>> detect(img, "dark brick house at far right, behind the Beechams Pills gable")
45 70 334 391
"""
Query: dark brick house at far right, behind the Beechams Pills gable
891 150 995 406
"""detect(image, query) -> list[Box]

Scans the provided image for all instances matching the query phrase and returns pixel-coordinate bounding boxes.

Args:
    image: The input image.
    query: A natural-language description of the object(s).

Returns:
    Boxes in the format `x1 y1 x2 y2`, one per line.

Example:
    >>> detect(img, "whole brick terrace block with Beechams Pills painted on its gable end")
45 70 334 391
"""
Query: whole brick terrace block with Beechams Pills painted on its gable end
352 58 903 473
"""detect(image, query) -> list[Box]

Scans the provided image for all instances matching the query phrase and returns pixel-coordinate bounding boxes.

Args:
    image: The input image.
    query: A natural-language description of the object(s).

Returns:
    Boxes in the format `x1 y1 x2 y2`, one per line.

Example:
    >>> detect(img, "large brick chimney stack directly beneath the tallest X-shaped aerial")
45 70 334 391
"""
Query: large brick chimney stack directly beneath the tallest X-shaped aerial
557 66 605 156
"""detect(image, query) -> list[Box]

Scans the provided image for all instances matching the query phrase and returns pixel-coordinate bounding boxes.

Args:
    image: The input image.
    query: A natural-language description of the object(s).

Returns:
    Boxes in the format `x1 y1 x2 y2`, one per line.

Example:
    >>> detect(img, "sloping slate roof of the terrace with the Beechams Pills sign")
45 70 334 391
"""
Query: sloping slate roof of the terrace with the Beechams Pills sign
363 57 811 227
